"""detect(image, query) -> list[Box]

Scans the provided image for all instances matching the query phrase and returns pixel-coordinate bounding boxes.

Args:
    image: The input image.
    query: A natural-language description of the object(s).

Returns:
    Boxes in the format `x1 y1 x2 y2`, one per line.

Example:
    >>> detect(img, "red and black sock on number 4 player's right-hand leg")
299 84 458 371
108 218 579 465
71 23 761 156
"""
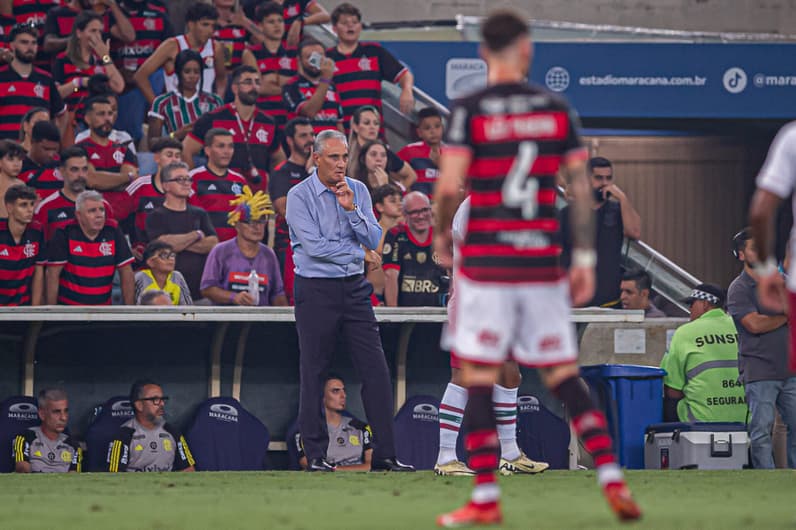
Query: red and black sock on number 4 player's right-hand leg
553 377 624 486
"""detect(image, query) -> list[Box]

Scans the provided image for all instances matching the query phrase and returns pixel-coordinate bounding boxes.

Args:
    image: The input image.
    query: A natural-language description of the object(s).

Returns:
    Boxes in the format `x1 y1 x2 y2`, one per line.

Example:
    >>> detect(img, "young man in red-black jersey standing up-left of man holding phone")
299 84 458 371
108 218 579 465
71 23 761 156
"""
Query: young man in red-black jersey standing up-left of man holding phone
243 2 298 129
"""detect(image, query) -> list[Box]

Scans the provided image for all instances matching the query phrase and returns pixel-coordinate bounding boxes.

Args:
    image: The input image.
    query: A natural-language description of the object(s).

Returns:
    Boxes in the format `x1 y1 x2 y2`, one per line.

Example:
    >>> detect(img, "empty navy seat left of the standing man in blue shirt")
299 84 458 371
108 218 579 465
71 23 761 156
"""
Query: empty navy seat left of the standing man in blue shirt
186 397 270 471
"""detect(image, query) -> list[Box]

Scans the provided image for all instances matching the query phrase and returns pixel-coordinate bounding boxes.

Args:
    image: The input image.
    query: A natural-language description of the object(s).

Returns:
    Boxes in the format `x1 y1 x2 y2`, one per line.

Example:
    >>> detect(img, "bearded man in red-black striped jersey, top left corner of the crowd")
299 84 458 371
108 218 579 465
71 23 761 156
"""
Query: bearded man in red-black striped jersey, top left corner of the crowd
0 25 67 140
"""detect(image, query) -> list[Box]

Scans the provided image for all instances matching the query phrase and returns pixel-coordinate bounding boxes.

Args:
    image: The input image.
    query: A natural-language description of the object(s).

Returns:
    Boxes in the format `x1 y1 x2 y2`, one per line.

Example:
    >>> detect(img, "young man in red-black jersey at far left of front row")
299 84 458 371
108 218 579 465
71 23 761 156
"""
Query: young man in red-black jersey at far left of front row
0 185 46 306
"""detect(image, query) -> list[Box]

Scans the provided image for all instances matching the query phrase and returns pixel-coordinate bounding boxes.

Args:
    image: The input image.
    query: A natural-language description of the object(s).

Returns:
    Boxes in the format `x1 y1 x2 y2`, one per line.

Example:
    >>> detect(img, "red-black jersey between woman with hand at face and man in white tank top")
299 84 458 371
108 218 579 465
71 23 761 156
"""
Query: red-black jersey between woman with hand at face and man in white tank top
111 2 174 72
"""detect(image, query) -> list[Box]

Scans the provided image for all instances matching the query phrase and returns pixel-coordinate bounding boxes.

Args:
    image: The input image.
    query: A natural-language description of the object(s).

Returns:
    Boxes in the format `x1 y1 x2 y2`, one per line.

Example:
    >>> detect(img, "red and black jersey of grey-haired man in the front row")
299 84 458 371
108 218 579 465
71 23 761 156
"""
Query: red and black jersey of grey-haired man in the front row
47 220 133 305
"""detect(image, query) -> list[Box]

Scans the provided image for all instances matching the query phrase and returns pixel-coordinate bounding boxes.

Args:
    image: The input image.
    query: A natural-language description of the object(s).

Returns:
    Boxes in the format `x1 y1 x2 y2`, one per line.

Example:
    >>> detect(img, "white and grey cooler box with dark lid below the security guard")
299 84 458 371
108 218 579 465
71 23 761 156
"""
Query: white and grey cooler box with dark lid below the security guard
644 423 749 469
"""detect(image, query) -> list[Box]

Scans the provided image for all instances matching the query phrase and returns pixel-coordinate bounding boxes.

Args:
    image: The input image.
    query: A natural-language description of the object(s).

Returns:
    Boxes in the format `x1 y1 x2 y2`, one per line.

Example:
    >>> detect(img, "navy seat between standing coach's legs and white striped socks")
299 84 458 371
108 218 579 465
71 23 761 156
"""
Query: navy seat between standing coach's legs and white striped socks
394 395 439 469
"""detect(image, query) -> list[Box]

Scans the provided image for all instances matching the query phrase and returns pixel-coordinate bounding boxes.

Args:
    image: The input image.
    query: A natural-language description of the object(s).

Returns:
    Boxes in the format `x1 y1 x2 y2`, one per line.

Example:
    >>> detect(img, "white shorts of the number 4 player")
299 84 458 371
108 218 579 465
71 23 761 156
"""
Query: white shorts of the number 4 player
445 274 578 367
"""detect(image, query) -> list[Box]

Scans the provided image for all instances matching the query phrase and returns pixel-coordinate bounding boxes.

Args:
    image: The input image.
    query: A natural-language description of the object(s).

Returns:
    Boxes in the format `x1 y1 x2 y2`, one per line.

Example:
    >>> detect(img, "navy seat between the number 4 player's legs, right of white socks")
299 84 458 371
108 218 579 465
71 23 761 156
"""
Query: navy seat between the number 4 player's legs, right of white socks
517 395 570 469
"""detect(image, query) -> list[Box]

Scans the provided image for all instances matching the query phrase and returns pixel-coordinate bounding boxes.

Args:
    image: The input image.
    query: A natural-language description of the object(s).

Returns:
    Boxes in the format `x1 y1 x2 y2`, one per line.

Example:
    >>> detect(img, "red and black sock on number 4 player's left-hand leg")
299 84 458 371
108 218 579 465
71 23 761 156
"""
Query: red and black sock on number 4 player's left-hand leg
463 386 500 509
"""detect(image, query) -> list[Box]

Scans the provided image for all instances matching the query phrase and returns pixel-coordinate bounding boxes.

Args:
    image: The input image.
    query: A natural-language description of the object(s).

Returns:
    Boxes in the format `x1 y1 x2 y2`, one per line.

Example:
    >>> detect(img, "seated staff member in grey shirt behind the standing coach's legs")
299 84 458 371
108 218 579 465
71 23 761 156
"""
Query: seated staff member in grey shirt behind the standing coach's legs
297 375 373 471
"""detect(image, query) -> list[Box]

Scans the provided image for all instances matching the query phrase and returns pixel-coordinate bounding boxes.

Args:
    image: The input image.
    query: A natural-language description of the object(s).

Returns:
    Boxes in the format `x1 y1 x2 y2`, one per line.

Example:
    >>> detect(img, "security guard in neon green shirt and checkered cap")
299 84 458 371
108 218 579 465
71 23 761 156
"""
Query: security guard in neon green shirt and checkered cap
661 283 747 423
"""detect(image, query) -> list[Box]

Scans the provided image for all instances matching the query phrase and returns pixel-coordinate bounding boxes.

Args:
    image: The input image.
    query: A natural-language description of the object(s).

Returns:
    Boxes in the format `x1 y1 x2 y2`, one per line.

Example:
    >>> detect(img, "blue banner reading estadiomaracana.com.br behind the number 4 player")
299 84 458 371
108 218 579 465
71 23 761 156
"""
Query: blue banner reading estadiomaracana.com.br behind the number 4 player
383 42 796 119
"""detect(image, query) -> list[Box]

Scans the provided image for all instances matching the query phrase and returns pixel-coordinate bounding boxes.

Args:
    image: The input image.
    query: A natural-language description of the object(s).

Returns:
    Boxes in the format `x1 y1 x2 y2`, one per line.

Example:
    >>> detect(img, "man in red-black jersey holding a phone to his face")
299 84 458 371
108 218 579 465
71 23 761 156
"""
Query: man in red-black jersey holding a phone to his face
282 38 343 134
